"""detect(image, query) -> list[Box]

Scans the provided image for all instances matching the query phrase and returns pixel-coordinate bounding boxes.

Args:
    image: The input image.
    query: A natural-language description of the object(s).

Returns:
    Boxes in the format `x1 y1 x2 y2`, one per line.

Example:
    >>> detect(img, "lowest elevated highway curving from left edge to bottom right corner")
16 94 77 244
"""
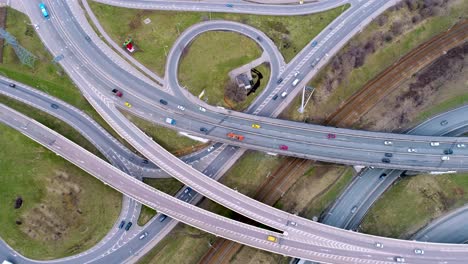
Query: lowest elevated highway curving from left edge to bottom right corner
4 102 468 263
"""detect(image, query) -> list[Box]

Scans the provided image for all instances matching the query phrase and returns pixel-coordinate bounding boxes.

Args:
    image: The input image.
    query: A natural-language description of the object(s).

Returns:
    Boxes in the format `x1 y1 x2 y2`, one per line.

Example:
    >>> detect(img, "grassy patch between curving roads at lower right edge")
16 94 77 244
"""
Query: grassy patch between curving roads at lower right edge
361 173 468 239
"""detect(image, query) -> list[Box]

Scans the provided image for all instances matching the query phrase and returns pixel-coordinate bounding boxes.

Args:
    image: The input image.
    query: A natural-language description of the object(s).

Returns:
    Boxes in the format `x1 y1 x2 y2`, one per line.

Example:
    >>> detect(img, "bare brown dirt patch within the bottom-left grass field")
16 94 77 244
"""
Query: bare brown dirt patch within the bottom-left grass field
21 171 83 241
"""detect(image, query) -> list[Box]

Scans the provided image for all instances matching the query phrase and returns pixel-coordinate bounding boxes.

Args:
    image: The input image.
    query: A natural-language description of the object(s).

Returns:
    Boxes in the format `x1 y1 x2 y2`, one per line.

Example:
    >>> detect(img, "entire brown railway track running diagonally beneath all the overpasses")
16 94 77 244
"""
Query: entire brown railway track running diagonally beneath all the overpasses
198 20 468 264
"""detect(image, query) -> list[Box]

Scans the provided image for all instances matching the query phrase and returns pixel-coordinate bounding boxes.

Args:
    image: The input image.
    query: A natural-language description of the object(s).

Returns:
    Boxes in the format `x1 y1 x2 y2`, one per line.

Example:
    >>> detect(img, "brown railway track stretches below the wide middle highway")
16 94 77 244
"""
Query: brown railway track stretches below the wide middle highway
198 158 313 264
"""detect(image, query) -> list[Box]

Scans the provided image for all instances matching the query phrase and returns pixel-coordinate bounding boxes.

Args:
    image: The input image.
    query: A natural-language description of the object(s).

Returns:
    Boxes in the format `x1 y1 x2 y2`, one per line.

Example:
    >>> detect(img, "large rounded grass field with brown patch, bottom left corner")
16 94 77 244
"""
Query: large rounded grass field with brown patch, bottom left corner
0 124 122 259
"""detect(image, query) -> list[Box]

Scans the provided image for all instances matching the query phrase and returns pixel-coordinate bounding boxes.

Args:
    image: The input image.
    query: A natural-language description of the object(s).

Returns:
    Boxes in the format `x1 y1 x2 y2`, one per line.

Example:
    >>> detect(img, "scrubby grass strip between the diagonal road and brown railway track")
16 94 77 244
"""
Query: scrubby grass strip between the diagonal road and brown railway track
284 0 468 123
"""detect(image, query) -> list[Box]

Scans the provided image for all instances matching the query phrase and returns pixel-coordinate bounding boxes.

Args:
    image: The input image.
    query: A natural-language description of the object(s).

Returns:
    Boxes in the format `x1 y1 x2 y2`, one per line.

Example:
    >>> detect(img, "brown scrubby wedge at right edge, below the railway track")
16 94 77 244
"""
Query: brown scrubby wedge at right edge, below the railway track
359 43 468 131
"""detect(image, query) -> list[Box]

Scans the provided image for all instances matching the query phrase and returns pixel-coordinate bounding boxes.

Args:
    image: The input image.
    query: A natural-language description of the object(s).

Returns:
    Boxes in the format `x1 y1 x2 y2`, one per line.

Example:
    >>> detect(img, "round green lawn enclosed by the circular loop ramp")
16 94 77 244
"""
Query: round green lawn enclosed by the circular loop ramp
179 32 270 107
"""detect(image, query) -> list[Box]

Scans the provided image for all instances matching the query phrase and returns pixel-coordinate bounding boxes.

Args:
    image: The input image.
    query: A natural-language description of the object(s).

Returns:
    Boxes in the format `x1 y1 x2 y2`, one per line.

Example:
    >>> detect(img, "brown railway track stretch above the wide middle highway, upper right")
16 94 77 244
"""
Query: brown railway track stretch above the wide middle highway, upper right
325 20 468 127
